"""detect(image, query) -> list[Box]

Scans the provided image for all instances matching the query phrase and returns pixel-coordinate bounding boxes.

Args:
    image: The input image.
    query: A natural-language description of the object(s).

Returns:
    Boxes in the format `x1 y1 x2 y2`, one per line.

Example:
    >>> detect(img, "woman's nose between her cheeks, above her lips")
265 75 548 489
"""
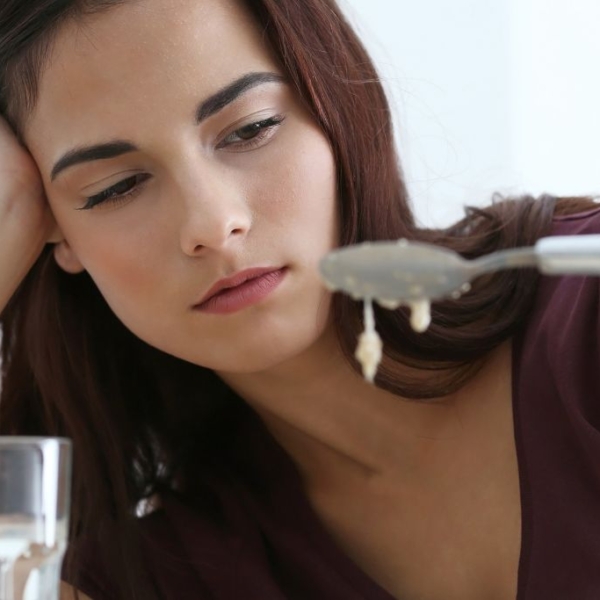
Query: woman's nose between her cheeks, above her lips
180 172 252 256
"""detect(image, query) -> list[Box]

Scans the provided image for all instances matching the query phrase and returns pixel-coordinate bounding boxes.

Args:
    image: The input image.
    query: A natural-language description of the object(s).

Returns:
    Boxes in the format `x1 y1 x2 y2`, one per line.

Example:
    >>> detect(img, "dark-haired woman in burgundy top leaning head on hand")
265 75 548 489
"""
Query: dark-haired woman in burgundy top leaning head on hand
0 0 600 600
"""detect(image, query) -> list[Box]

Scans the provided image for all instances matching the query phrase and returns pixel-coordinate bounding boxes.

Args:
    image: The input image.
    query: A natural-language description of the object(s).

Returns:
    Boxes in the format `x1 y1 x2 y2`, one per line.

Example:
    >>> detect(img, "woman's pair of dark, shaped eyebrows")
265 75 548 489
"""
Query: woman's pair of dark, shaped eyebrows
50 72 285 181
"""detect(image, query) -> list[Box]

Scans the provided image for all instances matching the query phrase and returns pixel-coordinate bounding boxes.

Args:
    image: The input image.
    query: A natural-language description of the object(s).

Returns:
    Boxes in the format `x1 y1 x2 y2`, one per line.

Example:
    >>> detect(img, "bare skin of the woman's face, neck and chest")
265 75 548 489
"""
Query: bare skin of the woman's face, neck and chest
16 0 520 600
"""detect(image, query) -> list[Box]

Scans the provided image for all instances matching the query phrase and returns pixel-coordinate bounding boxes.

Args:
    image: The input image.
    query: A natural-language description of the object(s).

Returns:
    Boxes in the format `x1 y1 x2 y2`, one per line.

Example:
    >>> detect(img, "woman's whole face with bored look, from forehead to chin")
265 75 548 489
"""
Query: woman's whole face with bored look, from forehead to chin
25 0 337 372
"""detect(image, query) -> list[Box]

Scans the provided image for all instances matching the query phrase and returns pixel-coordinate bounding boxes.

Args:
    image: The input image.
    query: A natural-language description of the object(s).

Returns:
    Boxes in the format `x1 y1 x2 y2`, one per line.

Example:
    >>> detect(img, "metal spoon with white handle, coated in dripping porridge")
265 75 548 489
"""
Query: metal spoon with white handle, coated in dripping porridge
320 235 600 309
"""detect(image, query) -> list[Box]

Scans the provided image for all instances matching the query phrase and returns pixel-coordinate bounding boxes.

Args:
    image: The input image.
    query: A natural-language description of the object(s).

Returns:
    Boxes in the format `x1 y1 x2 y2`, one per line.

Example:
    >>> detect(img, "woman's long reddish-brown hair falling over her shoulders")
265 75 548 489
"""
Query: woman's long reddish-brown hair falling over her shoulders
0 0 590 600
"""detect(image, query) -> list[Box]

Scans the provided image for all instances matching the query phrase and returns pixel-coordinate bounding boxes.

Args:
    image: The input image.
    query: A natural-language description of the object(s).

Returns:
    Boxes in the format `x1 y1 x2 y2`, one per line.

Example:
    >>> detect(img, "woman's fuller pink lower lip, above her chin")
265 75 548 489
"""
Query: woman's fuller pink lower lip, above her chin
195 269 287 315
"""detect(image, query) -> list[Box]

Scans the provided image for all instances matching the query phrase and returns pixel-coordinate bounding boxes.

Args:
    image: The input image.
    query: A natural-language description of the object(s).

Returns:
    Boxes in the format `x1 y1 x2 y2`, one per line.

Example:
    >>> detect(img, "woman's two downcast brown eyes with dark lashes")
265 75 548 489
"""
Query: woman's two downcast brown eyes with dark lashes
78 116 285 210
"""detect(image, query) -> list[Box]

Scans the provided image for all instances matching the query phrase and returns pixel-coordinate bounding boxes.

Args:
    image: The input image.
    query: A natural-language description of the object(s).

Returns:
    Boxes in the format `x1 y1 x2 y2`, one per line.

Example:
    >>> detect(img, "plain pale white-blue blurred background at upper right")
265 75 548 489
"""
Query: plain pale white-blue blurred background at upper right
339 0 600 225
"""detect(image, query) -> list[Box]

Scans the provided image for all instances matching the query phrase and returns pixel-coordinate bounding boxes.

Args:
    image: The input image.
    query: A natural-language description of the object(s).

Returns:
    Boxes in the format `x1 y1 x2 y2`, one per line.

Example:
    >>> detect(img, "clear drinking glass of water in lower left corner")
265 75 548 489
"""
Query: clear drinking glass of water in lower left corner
0 436 71 600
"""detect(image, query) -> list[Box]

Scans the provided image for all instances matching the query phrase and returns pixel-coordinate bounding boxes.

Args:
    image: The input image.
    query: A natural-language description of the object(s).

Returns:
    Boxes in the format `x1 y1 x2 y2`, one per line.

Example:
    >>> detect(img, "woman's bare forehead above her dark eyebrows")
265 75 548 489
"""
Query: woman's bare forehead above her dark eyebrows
25 0 276 156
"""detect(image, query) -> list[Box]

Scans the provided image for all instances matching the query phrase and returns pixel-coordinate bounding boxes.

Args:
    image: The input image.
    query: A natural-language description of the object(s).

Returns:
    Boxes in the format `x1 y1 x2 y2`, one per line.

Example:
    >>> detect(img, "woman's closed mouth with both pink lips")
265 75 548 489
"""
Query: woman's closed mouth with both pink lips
194 267 287 314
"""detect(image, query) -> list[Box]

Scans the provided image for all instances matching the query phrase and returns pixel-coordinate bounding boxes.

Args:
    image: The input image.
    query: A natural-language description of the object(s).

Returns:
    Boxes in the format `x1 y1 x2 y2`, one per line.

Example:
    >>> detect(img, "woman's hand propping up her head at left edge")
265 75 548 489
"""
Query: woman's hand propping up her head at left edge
0 117 56 312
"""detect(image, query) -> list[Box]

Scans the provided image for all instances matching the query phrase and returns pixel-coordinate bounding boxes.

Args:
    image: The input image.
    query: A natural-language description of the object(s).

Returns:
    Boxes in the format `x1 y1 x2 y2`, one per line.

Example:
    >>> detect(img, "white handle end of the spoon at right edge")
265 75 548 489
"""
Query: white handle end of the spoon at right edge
535 234 600 275
